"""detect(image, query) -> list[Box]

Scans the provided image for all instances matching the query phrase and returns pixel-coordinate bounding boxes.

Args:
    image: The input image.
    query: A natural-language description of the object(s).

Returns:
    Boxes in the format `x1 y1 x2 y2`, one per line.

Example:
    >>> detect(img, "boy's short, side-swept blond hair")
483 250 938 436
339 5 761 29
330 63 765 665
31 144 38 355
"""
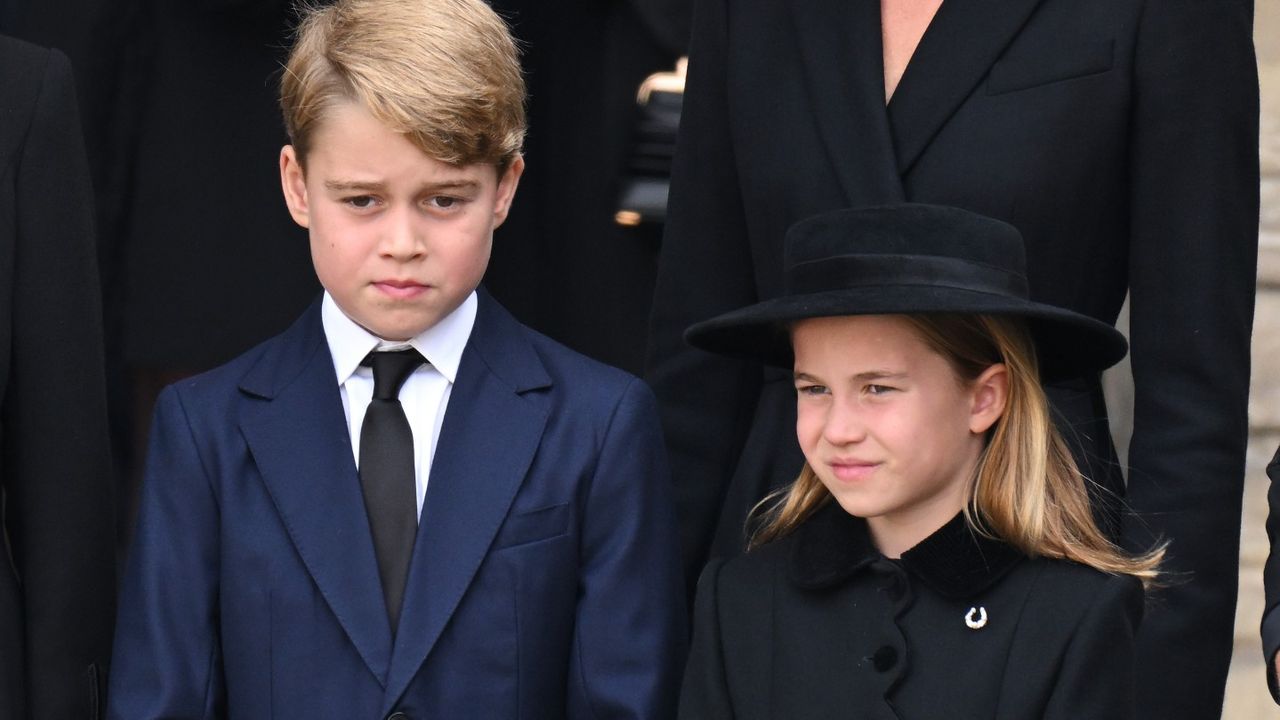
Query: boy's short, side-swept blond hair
280 0 525 170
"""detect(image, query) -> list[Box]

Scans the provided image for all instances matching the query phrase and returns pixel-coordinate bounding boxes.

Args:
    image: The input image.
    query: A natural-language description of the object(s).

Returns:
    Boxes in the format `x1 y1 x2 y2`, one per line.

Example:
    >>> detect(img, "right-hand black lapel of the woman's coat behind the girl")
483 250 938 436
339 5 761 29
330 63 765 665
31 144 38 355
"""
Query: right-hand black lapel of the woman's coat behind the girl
876 0 1041 176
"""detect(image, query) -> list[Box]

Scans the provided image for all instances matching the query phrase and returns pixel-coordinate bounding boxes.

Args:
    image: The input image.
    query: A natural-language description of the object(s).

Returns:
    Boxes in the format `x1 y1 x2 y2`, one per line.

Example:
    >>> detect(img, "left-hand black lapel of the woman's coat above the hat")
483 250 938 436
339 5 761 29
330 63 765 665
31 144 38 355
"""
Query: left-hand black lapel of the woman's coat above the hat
791 0 905 206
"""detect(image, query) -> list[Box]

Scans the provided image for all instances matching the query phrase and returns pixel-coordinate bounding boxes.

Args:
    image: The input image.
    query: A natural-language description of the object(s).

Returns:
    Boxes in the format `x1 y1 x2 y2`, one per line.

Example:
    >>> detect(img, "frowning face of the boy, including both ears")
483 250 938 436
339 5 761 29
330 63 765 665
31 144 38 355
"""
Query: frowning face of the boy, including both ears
280 102 525 340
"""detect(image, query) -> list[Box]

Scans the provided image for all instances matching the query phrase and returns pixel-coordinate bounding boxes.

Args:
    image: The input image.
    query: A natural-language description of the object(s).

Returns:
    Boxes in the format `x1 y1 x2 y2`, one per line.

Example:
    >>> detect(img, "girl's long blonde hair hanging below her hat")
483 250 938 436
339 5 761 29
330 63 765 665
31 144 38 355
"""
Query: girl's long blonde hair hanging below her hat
751 314 1165 587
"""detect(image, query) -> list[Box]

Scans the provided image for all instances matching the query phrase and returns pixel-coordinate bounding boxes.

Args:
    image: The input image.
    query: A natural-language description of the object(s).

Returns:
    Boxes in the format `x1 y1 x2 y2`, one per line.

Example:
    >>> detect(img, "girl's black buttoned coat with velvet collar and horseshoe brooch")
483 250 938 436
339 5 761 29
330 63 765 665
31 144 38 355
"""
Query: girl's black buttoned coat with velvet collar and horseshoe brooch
680 502 1142 720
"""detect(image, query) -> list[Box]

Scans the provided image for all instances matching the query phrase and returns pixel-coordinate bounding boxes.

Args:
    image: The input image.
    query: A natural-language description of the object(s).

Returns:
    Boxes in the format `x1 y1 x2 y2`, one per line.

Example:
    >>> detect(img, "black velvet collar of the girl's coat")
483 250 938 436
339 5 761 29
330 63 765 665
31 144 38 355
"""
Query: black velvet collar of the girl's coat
790 502 1024 600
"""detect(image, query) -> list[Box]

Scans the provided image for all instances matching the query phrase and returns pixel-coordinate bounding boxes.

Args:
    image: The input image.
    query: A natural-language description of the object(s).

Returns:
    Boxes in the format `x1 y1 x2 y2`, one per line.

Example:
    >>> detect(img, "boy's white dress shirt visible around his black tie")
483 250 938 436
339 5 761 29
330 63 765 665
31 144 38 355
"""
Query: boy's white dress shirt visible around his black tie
320 292 477 518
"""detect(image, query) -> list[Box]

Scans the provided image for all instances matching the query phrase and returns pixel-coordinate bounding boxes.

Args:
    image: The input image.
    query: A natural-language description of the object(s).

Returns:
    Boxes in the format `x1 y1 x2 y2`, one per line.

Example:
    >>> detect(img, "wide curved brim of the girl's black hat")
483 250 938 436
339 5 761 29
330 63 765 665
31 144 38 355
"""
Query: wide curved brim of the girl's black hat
685 286 1129 380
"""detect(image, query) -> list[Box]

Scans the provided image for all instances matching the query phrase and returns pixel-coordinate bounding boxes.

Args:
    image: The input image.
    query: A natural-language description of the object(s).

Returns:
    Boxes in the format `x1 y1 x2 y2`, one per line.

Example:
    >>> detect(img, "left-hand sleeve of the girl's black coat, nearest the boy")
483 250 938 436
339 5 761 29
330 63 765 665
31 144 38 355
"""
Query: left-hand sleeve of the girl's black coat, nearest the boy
680 560 733 720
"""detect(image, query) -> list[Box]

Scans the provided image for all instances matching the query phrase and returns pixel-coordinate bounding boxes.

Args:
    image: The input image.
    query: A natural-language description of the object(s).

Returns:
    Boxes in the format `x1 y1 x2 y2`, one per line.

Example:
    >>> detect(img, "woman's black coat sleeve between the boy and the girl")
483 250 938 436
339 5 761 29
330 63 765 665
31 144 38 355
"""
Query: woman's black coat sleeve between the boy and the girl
648 0 760 585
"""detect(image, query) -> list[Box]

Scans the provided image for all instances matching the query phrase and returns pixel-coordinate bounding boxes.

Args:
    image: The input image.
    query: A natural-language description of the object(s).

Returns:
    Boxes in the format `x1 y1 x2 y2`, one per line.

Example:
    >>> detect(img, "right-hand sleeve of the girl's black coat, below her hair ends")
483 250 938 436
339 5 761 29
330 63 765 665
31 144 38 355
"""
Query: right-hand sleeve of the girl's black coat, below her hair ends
1042 575 1146 720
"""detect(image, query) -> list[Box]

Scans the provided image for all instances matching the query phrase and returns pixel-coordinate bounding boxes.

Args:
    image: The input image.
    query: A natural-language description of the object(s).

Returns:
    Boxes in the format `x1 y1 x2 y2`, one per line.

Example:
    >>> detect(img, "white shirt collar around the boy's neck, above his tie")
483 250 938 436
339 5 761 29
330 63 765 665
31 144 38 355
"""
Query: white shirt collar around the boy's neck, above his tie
320 291 477 386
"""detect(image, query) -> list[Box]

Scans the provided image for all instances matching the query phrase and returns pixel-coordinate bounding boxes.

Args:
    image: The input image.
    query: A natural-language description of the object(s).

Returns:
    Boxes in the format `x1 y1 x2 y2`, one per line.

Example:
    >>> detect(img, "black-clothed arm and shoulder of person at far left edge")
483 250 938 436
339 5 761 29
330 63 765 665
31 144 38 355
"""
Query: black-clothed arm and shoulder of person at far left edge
0 37 115 719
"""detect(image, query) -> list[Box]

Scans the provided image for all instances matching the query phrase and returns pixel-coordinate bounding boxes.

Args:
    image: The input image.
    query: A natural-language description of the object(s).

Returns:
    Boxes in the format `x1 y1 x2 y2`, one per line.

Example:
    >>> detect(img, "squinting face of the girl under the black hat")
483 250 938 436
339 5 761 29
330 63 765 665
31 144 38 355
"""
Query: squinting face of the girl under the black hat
791 315 1007 557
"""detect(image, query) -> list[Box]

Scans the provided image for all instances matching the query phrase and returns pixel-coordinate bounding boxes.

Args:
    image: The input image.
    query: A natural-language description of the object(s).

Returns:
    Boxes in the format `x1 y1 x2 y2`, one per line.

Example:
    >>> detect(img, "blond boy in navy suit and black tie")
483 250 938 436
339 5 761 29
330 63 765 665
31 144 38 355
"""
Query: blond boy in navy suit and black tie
109 0 685 720
